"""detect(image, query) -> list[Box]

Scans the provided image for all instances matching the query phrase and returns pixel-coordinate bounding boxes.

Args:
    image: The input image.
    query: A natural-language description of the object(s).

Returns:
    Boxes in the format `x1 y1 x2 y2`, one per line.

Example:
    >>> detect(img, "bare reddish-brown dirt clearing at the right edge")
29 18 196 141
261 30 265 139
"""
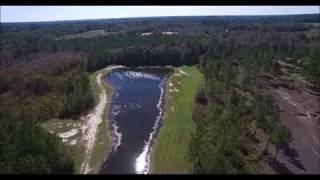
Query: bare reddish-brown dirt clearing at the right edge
265 79 320 174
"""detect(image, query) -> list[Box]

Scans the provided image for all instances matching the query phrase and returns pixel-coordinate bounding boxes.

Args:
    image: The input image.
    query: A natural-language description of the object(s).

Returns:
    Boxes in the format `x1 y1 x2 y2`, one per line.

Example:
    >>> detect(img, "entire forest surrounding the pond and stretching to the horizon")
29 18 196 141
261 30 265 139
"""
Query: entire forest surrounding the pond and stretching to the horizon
0 14 320 173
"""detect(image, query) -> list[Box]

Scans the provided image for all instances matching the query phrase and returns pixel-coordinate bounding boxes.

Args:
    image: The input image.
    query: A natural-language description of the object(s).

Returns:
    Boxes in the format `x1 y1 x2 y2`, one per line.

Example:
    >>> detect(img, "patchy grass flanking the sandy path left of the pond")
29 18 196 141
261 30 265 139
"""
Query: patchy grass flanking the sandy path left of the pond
43 69 112 174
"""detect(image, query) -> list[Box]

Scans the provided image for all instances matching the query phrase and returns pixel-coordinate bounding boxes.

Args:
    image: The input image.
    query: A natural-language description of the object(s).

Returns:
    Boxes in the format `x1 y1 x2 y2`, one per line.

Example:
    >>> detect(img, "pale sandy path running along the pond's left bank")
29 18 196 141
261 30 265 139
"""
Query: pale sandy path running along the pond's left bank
81 66 122 174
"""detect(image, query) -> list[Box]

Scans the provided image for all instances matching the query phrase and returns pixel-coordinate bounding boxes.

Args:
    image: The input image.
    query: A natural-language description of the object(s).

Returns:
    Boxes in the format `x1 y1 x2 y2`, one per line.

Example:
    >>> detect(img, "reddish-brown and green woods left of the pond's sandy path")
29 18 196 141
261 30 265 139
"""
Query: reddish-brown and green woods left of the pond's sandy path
0 53 93 121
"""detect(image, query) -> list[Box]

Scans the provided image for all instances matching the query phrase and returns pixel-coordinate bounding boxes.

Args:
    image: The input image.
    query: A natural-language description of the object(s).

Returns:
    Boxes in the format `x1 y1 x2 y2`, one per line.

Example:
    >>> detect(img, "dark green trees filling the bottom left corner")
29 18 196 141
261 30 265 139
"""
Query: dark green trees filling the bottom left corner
0 117 73 174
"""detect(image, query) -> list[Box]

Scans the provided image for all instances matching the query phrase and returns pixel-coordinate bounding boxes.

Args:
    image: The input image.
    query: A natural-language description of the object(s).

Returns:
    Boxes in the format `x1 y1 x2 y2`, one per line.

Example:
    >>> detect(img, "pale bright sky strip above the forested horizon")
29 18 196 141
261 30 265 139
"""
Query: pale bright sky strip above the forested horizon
0 6 320 22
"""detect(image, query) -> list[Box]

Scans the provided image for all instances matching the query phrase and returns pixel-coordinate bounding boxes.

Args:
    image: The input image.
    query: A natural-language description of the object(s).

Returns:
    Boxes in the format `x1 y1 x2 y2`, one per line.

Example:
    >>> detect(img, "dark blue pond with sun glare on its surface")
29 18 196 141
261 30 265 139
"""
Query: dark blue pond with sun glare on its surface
101 68 170 174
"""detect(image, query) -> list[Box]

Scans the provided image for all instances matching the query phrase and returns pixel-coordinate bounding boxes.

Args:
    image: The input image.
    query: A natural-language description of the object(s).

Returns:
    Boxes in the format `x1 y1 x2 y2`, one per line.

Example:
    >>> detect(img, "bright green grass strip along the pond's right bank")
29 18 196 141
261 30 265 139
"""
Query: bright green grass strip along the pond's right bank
150 66 203 173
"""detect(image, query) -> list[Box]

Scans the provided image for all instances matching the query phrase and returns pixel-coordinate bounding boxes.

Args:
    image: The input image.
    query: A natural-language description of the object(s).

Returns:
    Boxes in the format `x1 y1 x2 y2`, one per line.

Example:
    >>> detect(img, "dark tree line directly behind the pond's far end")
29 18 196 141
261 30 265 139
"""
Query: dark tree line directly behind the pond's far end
87 44 203 71
